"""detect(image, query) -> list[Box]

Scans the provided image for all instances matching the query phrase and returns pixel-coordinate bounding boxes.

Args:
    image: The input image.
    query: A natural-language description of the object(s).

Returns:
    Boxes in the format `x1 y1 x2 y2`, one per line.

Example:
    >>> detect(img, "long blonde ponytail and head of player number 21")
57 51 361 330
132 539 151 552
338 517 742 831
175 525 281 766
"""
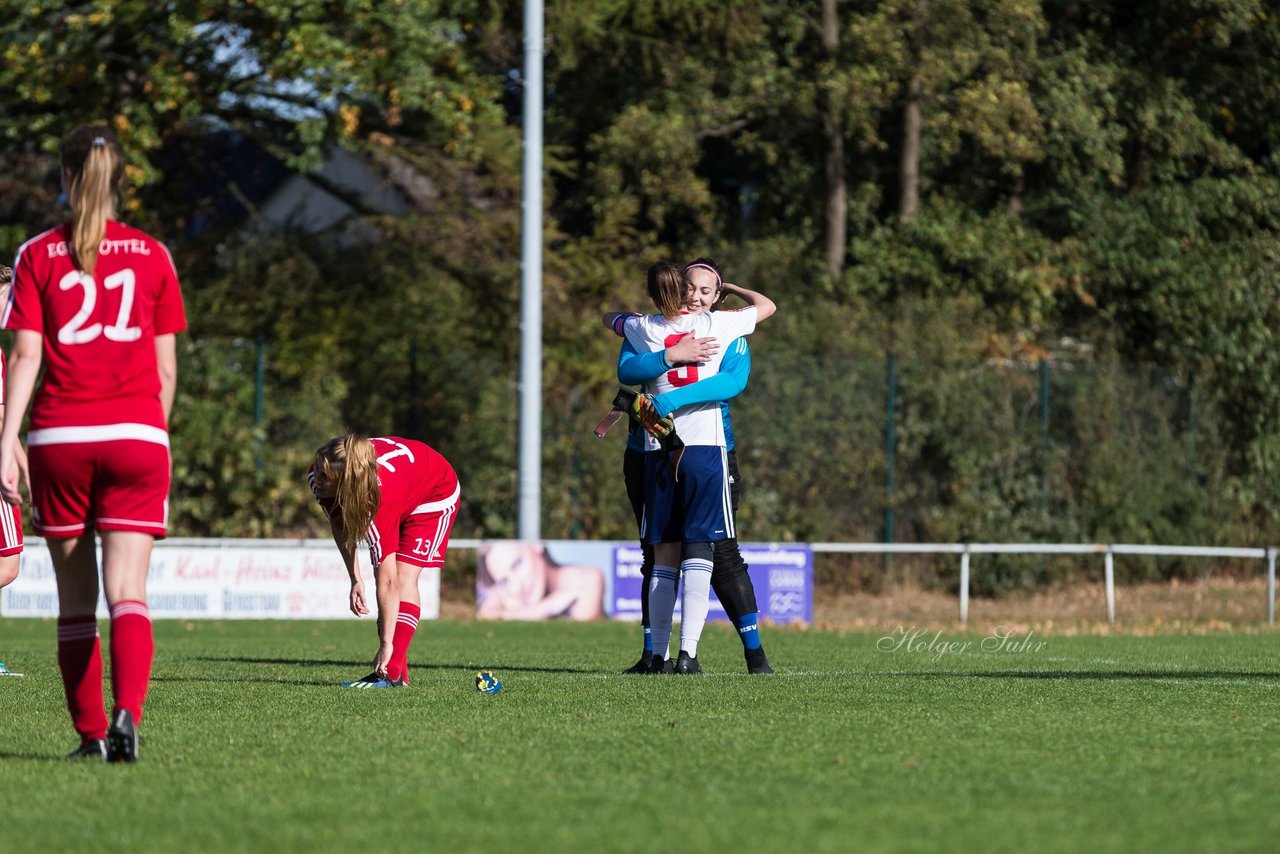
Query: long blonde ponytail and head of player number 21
61 124 124 273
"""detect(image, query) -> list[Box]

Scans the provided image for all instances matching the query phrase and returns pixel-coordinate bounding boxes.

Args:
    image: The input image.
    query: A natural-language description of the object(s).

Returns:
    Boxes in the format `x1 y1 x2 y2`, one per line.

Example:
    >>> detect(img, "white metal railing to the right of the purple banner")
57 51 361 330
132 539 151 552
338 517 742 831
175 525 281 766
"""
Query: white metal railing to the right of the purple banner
809 543 1277 625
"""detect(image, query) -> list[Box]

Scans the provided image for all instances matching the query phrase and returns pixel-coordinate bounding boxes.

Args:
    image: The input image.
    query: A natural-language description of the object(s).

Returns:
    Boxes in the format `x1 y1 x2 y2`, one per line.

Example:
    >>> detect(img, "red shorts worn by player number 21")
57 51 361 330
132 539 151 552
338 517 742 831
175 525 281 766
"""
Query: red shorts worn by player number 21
27 439 170 539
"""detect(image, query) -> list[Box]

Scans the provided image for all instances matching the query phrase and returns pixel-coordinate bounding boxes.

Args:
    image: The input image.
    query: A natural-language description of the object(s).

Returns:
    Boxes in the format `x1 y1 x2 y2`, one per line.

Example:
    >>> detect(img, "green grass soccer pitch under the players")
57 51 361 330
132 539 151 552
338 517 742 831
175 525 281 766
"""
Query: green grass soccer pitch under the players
0 620 1280 851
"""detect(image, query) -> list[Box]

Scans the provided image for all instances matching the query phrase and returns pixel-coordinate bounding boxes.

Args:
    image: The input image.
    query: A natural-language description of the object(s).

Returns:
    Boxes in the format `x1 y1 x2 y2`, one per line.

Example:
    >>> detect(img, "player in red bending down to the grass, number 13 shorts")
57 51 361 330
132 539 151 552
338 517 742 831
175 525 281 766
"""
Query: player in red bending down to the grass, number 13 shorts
307 433 462 688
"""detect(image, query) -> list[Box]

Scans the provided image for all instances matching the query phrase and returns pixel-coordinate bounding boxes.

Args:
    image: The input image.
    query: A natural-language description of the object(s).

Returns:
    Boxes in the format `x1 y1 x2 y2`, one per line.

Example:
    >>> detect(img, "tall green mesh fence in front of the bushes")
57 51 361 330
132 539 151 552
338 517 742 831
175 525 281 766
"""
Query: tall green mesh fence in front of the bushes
173 332 1280 594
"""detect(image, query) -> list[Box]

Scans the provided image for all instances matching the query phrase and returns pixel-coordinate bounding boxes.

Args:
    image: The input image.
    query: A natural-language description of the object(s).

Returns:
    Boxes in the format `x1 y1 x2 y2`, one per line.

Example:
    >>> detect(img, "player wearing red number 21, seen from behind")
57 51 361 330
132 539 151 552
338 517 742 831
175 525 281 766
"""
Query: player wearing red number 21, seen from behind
0 125 187 762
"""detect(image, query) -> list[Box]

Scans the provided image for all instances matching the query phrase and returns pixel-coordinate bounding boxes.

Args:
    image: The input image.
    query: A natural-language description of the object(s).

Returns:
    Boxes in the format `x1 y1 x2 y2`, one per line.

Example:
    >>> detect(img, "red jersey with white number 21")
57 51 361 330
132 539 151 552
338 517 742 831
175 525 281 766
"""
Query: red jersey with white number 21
0 220 187 429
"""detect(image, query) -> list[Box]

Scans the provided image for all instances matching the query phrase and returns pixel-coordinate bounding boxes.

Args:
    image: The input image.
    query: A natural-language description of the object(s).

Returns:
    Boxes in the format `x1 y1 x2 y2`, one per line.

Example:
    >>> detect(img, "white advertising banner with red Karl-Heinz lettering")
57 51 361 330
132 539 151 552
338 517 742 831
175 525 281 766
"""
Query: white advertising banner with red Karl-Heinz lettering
0 540 440 620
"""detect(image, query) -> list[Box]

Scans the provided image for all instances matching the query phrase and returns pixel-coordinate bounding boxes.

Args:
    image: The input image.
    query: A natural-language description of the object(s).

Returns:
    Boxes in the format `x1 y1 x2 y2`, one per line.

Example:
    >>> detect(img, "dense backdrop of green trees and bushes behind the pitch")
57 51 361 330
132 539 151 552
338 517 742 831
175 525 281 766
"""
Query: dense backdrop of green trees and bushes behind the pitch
0 0 1280 590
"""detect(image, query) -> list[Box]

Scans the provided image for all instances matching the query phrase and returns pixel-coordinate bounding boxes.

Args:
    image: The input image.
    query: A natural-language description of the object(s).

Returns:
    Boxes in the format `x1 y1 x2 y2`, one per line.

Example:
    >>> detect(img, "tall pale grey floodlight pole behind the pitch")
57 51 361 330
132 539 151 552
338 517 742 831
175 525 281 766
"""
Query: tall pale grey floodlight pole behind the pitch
517 0 544 540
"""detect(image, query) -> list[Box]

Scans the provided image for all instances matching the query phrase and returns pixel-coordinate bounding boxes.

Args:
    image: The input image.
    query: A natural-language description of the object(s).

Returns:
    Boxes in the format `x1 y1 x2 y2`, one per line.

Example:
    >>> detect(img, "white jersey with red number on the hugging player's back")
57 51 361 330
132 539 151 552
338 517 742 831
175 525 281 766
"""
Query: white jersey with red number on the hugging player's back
622 306 758 451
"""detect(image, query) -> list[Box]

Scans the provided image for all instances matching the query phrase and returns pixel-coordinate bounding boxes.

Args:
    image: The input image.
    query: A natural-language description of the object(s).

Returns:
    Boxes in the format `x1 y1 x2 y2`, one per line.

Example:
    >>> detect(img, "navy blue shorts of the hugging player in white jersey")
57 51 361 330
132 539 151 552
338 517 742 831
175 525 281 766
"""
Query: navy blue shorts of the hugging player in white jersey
640 446 735 543
